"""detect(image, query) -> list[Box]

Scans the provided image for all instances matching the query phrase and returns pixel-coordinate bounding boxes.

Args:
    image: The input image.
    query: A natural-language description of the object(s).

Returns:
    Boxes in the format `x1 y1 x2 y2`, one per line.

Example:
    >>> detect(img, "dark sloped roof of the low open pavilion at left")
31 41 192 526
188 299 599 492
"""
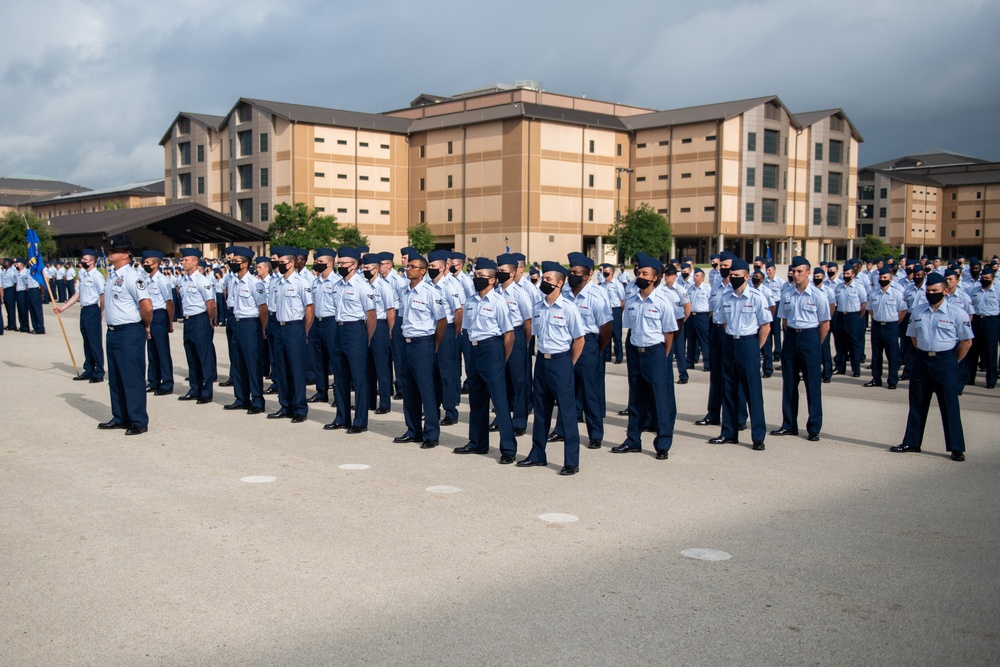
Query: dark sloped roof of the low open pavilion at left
49 204 267 243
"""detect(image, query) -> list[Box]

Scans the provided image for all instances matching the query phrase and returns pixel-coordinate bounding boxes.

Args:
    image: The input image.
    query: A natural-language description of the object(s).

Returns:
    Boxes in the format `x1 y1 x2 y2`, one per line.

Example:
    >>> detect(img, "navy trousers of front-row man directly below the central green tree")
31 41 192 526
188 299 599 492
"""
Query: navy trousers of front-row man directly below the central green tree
623 343 677 452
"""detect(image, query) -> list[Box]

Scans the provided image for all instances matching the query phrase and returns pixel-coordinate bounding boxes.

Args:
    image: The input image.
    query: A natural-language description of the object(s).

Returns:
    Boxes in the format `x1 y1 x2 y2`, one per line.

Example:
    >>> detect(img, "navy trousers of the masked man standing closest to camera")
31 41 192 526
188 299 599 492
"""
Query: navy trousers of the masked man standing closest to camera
525 352 580 467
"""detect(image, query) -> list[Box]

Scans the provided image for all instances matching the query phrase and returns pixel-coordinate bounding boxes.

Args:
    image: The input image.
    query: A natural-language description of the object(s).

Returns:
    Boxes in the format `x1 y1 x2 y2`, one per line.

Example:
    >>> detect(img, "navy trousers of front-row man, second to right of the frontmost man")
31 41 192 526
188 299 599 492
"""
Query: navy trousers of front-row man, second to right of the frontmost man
722 334 767 442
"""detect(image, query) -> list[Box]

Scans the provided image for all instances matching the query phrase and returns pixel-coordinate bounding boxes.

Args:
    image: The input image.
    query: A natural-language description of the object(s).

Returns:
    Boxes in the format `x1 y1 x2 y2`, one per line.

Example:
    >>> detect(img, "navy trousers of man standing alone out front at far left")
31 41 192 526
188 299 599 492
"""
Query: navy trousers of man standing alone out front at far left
106 322 149 428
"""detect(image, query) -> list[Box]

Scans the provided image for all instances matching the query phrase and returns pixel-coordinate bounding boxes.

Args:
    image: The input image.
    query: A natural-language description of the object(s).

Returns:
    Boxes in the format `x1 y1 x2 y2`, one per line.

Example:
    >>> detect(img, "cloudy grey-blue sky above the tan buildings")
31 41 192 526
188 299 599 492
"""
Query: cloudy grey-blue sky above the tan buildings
0 0 1000 188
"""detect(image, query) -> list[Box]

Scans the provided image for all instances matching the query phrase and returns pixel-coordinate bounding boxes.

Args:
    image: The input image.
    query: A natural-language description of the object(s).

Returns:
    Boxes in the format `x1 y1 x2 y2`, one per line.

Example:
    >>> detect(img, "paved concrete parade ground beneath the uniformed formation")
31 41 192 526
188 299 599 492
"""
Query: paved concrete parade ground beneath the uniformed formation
0 306 1000 666
